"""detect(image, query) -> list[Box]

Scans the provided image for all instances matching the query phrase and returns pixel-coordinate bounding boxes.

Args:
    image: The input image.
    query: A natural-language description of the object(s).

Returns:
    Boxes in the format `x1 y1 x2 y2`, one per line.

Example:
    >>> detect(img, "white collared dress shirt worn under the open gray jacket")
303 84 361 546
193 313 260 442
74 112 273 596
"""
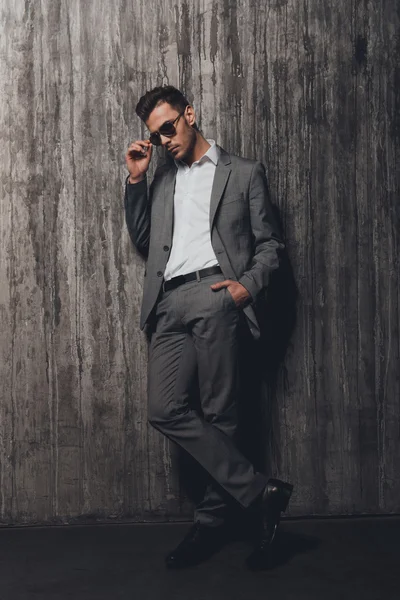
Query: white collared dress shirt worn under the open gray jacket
164 140 219 281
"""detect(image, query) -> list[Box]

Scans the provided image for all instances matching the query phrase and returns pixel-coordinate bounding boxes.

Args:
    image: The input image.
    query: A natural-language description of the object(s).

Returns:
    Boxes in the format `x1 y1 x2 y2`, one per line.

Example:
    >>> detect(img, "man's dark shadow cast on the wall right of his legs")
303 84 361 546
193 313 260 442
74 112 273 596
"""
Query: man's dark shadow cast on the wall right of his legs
239 206 298 476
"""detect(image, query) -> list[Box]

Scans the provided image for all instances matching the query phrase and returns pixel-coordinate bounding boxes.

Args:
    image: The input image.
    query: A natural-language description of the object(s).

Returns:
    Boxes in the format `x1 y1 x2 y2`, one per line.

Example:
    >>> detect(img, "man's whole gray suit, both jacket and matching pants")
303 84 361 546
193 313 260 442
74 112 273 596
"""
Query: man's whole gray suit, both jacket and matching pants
125 148 283 525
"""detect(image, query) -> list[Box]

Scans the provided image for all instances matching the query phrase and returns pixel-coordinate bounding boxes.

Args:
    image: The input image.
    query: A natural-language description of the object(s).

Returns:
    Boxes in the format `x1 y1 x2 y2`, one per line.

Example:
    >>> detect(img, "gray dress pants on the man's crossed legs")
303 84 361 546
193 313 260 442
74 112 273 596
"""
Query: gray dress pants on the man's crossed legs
148 274 267 526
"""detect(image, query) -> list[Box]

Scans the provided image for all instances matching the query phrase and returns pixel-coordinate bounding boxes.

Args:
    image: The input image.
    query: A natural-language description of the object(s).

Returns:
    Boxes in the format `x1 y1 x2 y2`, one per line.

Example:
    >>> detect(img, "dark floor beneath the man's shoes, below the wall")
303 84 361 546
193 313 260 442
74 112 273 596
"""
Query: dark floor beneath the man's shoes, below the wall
0 517 400 600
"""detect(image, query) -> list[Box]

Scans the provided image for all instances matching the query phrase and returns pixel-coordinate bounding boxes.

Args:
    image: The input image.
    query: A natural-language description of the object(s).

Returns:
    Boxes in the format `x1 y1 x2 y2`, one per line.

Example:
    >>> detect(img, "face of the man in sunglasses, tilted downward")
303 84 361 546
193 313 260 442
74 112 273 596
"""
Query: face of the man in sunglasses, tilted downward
146 102 196 160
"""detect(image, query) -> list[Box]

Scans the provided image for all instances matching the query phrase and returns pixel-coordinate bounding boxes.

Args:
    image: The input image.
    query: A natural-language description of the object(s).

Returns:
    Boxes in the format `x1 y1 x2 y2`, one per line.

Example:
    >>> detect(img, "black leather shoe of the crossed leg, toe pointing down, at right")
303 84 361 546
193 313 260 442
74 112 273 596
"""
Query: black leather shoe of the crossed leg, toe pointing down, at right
246 479 293 571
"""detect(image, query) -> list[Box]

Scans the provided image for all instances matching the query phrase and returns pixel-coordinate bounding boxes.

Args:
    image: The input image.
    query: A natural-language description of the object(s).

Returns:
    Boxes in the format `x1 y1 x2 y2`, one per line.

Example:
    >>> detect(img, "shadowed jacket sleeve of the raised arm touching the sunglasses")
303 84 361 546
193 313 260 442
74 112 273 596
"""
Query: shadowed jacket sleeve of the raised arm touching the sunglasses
124 175 151 258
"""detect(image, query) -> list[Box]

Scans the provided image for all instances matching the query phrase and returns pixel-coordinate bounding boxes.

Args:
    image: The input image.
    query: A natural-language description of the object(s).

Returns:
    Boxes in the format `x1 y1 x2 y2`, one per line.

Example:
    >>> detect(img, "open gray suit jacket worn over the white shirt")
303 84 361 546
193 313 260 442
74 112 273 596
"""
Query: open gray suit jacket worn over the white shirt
125 146 284 339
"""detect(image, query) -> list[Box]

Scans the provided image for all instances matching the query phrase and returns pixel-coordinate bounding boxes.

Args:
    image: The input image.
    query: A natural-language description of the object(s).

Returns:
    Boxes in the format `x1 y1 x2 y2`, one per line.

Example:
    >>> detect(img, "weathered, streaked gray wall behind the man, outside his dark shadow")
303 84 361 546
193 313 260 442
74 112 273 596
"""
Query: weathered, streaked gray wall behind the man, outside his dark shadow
0 0 400 523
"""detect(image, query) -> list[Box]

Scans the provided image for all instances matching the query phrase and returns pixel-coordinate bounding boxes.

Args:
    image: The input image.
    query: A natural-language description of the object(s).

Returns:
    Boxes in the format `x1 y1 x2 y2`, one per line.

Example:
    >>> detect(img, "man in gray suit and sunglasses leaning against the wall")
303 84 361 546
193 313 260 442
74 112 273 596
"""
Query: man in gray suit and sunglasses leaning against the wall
125 86 292 569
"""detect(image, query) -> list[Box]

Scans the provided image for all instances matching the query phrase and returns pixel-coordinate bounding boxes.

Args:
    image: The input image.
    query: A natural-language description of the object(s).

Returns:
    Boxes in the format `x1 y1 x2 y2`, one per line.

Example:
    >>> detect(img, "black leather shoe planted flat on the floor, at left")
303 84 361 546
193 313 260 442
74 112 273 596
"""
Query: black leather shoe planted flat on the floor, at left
165 521 225 569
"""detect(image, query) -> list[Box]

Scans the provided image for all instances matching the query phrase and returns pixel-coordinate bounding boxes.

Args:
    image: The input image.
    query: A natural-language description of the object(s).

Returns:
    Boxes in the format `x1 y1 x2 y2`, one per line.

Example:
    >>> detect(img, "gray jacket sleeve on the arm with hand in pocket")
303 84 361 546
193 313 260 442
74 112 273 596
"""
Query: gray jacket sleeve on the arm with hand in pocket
239 162 285 300
